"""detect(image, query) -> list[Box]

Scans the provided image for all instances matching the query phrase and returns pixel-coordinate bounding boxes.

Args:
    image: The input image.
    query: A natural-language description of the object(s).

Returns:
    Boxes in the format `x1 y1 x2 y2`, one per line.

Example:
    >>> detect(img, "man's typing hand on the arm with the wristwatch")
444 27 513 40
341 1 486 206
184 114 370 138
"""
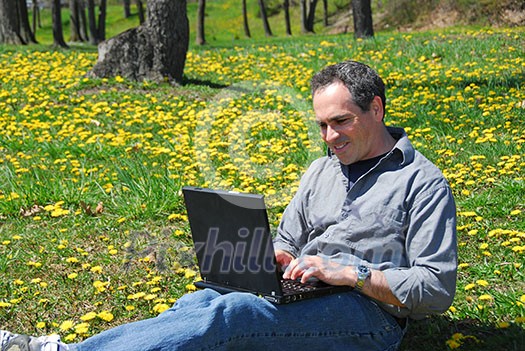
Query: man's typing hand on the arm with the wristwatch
283 256 355 286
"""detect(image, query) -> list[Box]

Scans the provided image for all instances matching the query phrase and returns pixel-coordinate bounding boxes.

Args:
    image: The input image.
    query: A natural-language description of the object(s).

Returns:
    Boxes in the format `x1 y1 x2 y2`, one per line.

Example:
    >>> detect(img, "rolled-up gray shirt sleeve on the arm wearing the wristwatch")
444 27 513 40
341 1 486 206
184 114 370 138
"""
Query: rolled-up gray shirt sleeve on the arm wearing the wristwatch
384 185 457 319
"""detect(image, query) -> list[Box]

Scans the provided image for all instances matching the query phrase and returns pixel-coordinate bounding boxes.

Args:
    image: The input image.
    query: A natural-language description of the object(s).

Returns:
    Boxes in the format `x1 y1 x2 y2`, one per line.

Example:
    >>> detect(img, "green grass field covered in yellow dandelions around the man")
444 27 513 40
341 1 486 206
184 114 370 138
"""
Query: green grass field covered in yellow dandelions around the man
0 28 525 350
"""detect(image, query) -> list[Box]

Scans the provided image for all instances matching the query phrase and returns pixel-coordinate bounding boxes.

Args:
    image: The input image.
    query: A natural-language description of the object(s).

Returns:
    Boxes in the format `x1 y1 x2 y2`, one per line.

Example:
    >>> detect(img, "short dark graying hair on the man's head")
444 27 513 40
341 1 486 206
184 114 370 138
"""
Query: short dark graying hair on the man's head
311 61 386 115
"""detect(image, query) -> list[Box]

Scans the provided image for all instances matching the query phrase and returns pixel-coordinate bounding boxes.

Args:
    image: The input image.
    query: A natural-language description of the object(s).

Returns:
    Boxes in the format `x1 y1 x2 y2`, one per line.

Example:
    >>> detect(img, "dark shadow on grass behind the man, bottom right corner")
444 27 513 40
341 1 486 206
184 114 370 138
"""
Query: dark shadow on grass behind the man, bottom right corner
399 316 525 351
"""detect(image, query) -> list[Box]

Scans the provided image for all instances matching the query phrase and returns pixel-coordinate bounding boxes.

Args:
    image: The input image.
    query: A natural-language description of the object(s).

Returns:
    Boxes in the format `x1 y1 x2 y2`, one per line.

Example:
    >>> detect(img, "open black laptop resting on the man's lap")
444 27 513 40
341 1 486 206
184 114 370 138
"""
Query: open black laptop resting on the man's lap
182 186 352 304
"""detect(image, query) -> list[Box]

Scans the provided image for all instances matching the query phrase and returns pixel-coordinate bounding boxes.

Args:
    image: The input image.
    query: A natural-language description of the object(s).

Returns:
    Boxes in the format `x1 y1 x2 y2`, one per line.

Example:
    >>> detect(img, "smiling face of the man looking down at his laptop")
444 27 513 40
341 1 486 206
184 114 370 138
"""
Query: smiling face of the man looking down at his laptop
313 82 383 165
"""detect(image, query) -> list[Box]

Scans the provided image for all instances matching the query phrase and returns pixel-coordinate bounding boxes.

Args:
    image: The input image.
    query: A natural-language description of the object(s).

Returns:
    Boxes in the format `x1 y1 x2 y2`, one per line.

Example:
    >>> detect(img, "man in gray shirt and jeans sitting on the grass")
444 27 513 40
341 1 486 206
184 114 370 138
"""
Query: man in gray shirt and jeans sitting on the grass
0 61 457 351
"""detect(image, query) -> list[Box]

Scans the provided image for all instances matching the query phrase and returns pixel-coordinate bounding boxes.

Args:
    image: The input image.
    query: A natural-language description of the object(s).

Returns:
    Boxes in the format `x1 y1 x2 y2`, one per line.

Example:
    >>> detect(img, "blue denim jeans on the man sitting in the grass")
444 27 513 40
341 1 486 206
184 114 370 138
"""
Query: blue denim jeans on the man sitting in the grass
70 289 404 351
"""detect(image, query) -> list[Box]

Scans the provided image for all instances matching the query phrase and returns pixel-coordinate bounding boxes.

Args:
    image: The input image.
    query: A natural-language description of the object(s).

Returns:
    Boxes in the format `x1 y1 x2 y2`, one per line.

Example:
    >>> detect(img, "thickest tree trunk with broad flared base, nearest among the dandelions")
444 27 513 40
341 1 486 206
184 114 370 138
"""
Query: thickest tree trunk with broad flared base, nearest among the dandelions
88 0 189 82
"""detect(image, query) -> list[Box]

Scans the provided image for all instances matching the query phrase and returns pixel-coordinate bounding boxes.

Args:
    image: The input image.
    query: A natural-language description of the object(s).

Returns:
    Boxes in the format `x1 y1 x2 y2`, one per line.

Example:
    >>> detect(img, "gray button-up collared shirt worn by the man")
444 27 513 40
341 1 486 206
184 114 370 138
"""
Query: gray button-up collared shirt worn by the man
274 128 457 319
